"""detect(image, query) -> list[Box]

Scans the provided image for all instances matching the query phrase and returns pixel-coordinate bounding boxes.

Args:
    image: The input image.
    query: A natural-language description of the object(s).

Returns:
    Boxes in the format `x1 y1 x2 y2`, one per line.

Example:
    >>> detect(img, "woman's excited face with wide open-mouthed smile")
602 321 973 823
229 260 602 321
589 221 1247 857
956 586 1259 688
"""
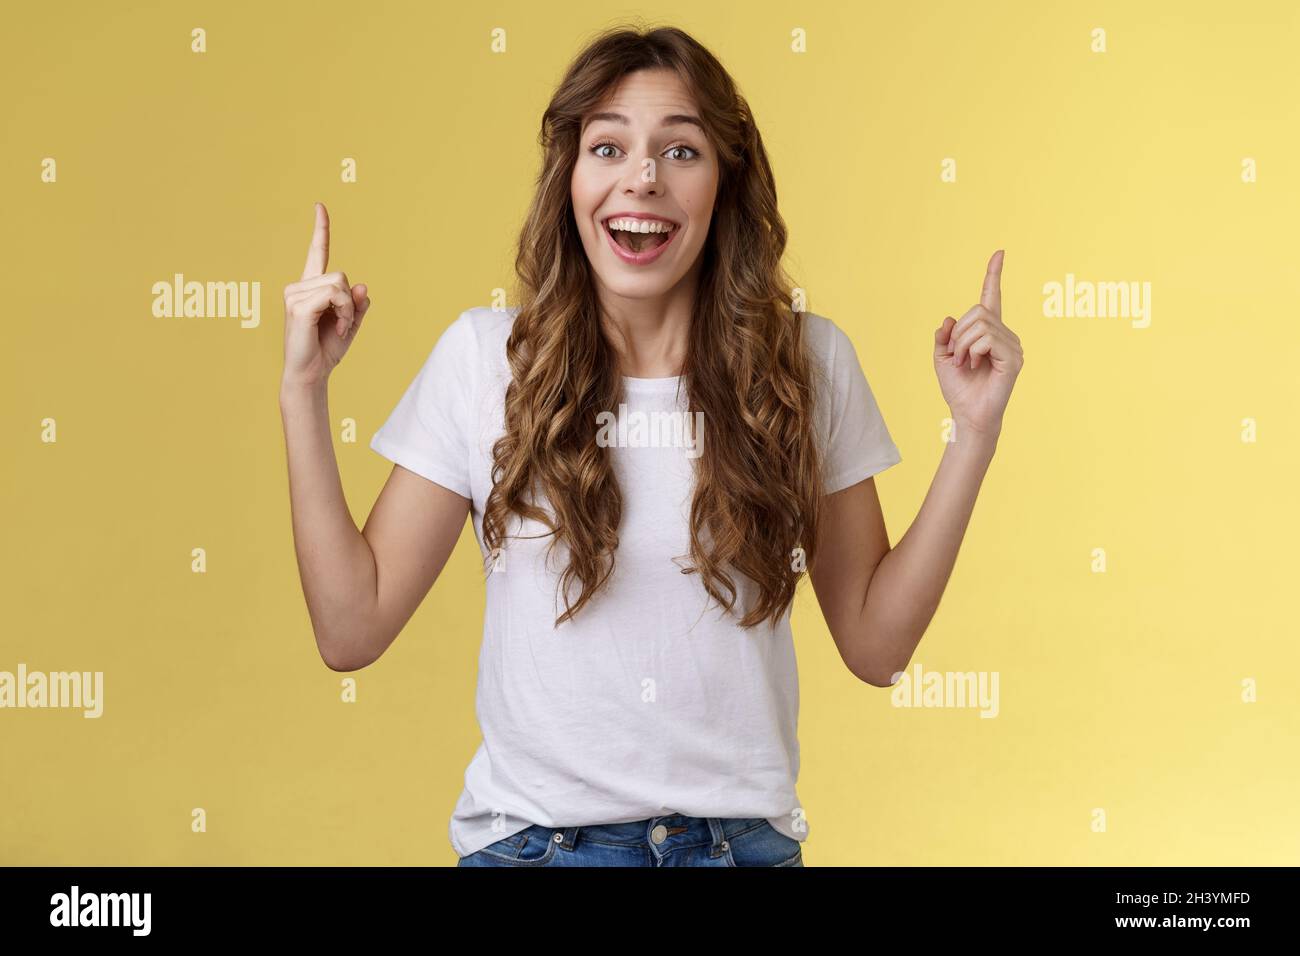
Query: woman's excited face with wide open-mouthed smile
569 69 718 299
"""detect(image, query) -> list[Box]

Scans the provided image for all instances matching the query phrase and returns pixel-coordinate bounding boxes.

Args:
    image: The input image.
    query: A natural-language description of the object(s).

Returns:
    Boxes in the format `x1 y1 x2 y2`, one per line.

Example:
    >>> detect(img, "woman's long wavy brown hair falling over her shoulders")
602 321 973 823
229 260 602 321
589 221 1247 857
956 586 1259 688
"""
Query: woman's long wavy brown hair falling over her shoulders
482 27 823 628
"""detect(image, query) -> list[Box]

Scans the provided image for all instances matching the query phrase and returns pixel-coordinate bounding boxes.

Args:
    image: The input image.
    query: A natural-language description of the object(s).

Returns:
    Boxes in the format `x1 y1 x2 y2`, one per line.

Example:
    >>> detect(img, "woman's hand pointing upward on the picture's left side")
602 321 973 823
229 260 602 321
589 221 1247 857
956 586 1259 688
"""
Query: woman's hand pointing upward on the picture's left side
282 203 371 386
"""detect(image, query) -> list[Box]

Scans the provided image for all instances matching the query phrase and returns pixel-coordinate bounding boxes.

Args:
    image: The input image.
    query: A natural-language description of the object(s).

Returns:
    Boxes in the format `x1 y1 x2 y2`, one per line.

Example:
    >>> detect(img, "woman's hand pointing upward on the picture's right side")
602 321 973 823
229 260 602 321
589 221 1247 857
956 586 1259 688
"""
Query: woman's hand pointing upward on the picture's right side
935 250 1024 440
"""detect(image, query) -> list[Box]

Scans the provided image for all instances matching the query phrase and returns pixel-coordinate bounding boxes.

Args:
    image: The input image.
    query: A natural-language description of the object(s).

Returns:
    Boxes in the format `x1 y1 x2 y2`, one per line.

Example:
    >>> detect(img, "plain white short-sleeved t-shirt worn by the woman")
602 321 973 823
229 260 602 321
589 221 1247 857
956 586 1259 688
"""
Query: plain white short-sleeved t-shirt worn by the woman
371 307 901 856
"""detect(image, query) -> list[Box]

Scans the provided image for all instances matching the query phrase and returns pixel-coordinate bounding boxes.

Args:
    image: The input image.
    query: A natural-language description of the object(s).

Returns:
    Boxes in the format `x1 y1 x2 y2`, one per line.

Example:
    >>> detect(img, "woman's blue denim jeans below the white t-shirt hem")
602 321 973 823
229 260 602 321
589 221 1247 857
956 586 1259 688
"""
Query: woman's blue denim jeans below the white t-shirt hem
456 814 803 866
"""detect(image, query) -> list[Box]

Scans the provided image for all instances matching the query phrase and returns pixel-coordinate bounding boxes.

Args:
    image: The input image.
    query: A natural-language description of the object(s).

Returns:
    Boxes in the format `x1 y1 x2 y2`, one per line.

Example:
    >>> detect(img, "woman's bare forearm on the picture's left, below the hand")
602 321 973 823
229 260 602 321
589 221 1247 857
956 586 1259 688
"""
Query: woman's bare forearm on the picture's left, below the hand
280 384 377 670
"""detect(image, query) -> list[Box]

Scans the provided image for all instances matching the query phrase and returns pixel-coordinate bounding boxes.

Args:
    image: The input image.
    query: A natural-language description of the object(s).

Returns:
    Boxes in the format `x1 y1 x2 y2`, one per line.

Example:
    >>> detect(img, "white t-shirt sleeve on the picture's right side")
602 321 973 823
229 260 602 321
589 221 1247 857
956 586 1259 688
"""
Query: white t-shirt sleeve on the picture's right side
823 324 902 494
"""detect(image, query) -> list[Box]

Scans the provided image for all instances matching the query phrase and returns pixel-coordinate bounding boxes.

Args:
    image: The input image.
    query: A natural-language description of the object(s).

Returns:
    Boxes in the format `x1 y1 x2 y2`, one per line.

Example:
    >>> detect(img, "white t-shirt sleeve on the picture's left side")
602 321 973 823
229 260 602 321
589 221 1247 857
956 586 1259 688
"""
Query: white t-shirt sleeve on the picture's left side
371 311 478 498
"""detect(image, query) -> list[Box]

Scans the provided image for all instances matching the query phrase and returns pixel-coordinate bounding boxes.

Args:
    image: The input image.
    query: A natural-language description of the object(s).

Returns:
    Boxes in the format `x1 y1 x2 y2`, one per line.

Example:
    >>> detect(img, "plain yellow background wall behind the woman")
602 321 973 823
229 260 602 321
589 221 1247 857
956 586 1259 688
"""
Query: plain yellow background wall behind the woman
0 0 1300 865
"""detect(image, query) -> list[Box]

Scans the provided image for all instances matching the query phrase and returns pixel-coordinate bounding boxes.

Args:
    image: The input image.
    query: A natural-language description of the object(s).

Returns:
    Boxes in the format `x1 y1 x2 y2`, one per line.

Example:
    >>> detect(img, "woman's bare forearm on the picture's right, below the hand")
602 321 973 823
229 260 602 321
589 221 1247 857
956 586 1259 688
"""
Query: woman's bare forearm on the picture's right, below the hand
859 434 997 685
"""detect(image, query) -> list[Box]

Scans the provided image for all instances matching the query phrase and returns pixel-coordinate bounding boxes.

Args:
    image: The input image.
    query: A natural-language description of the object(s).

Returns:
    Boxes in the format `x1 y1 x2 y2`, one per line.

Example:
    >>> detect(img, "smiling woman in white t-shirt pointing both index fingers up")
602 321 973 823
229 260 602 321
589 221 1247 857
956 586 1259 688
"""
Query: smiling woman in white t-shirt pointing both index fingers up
281 29 1023 866
